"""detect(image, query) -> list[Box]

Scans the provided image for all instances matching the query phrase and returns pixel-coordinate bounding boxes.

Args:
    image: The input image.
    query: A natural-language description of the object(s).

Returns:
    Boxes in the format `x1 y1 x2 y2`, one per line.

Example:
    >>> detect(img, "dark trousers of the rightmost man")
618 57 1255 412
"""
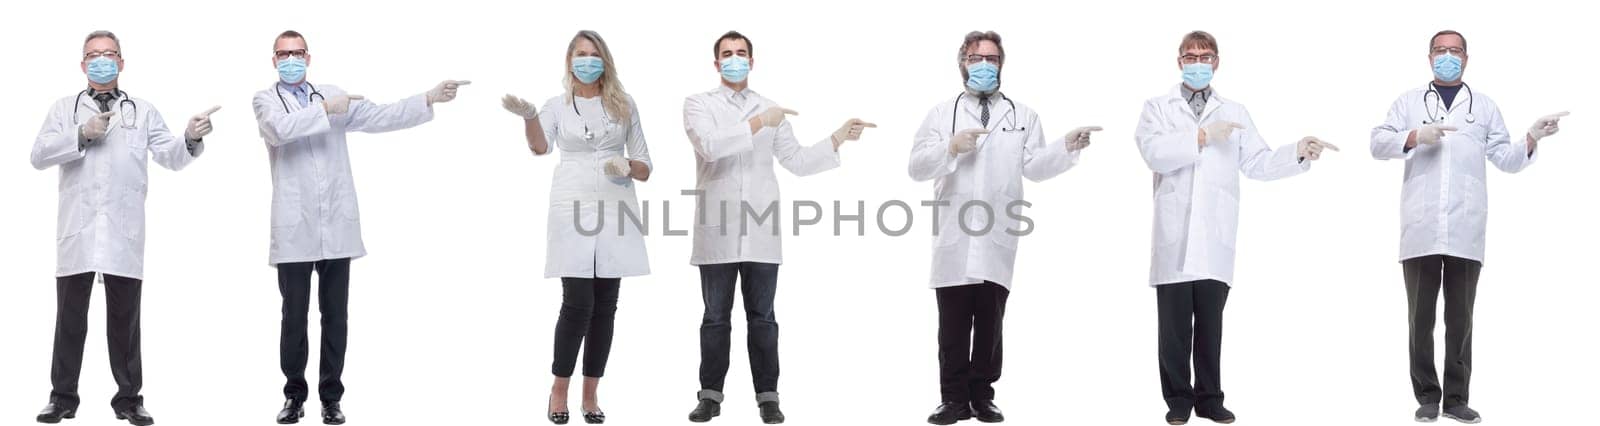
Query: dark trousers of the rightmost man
1400 255 1483 408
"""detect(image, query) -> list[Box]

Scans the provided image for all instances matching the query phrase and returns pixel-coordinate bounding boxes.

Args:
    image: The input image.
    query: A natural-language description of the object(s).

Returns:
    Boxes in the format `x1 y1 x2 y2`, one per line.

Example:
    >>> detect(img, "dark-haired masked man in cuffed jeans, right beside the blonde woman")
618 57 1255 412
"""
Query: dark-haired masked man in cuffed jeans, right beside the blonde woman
683 30 877 424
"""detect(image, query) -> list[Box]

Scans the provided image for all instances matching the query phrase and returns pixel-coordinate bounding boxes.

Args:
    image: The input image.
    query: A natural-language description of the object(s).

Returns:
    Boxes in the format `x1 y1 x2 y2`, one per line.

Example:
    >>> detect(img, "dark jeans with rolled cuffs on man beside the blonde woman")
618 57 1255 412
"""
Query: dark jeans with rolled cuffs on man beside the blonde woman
699 261 778 394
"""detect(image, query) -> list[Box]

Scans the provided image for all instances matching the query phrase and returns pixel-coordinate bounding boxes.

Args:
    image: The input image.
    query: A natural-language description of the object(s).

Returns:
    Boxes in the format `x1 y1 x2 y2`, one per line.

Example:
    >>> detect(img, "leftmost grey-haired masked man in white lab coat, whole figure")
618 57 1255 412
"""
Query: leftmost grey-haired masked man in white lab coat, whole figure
30 30 216 424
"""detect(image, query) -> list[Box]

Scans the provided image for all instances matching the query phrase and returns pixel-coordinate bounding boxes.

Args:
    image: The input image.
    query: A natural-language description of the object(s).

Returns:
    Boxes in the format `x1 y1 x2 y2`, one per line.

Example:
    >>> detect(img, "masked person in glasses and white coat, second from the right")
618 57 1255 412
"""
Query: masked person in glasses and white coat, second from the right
1134 30 1338 424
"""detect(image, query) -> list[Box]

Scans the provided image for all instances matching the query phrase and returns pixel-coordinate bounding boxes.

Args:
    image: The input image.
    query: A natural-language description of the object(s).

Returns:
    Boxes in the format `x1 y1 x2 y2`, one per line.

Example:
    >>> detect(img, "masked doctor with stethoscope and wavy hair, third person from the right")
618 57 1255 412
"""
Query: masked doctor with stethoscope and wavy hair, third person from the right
909 30 1099 424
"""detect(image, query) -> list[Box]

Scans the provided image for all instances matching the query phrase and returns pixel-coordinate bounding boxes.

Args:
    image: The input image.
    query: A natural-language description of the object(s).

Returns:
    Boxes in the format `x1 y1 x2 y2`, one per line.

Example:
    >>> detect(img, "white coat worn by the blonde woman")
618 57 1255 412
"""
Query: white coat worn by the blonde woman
539 94 653 279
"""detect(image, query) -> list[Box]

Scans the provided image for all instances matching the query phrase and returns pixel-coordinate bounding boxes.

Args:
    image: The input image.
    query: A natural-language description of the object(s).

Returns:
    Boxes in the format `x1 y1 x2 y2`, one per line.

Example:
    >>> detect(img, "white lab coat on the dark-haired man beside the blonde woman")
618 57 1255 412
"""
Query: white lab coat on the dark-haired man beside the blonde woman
683 85 838 266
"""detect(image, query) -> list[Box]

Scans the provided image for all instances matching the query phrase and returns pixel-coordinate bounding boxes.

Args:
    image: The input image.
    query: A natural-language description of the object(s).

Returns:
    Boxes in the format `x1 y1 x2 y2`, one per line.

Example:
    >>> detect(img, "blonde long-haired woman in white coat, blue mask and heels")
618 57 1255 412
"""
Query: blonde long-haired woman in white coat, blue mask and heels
504 30 651 423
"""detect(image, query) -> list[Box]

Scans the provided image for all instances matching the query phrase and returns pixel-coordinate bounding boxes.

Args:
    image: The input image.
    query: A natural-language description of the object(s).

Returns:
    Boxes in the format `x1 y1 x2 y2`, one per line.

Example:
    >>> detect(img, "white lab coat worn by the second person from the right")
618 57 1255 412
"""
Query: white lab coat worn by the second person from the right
1134 85 1310 287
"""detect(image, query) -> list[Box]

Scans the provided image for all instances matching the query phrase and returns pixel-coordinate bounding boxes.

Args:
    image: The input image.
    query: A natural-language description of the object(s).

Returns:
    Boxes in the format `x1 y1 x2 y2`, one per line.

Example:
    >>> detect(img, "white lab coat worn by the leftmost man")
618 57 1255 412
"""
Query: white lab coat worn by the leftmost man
30 94 203 280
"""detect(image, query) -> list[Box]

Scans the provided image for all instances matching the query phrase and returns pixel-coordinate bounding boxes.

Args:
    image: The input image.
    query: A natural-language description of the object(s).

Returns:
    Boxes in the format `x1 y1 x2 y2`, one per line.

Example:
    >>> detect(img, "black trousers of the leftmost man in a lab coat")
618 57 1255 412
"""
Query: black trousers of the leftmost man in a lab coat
50 272 144 410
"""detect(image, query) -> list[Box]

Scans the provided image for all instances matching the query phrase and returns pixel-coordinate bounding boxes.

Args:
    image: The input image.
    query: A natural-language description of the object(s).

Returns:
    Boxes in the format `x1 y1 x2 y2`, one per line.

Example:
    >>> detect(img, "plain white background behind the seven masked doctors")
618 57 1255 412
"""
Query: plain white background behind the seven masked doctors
0 2 1600 424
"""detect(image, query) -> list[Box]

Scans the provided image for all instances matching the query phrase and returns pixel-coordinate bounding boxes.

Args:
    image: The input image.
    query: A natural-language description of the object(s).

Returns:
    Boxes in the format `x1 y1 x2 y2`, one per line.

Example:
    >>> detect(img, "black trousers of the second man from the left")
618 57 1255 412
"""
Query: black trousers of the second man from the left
278 258 350 402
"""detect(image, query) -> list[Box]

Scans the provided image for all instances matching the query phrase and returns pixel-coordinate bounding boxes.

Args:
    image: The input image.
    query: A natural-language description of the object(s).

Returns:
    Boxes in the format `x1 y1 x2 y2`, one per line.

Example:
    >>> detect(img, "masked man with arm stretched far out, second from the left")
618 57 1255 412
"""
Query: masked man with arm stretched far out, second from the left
253 30 467 424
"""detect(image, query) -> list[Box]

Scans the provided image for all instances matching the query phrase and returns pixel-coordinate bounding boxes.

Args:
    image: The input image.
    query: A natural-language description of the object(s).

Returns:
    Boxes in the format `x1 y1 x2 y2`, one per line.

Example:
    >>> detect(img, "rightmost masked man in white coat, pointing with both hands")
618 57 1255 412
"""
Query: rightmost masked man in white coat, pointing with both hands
1371 30 1566 421
